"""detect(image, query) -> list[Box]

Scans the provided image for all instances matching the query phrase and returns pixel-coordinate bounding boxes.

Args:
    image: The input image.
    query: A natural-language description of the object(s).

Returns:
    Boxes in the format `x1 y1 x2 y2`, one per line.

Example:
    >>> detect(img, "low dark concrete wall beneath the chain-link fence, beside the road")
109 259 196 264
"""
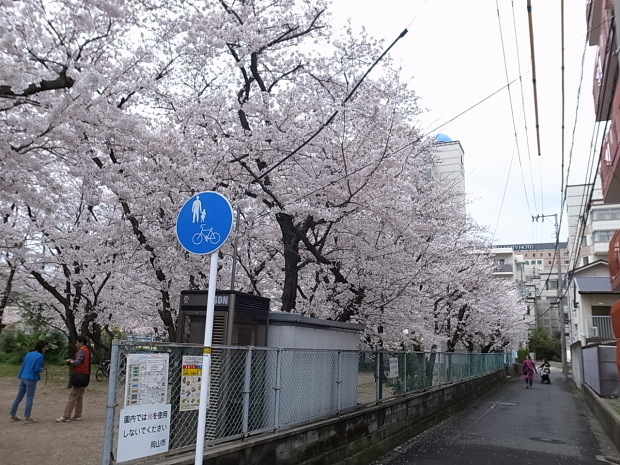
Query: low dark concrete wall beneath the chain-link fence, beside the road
158 370 507 465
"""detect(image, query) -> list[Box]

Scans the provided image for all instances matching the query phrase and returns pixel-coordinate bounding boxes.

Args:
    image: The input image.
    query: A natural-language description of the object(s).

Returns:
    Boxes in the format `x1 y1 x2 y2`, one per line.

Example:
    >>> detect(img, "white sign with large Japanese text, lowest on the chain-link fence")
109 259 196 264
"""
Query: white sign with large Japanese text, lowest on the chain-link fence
116 404 170 463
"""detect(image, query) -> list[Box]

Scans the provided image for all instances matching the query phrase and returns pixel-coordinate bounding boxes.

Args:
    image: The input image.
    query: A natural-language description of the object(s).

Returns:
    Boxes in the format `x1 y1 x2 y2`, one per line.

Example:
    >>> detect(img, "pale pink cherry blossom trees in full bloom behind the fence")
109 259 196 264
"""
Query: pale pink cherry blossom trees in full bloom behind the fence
0 0 528 350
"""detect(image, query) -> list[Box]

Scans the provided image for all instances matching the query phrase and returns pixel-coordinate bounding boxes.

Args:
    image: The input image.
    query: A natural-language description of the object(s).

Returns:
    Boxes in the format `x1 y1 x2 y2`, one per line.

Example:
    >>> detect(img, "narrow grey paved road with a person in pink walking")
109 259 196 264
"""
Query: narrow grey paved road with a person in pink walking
375 369 620 465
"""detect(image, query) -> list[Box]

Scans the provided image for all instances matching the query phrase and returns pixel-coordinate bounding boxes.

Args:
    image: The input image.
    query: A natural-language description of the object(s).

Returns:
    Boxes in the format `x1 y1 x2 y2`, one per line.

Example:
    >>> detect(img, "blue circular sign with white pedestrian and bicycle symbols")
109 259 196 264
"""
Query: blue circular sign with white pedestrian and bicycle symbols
176 191 233 255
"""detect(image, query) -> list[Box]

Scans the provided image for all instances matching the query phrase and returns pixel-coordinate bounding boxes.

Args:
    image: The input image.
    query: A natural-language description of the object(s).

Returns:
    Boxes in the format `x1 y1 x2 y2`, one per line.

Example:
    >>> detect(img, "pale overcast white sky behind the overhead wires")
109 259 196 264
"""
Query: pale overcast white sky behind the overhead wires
334 0 598 245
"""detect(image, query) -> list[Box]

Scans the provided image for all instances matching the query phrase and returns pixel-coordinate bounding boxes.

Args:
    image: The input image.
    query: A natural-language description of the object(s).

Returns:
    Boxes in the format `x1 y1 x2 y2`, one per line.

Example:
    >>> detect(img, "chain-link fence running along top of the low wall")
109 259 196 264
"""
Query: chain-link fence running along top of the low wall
102 341 506 465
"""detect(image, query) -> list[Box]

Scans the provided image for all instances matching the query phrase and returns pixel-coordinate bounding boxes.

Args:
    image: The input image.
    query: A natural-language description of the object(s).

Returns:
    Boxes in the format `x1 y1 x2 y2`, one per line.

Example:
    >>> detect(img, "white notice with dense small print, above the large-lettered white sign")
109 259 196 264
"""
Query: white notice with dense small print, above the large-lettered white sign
125 354 169 407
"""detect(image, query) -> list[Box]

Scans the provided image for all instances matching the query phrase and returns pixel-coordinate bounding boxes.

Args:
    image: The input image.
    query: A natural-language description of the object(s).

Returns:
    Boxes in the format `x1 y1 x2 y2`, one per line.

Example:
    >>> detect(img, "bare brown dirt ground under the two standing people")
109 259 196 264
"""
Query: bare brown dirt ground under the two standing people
0 376 108 465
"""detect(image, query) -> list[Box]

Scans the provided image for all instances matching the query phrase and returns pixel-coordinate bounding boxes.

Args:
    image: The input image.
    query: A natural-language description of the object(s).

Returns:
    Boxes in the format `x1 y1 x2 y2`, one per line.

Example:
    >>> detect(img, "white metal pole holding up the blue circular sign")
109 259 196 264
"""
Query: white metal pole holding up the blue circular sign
194 252 222 465
